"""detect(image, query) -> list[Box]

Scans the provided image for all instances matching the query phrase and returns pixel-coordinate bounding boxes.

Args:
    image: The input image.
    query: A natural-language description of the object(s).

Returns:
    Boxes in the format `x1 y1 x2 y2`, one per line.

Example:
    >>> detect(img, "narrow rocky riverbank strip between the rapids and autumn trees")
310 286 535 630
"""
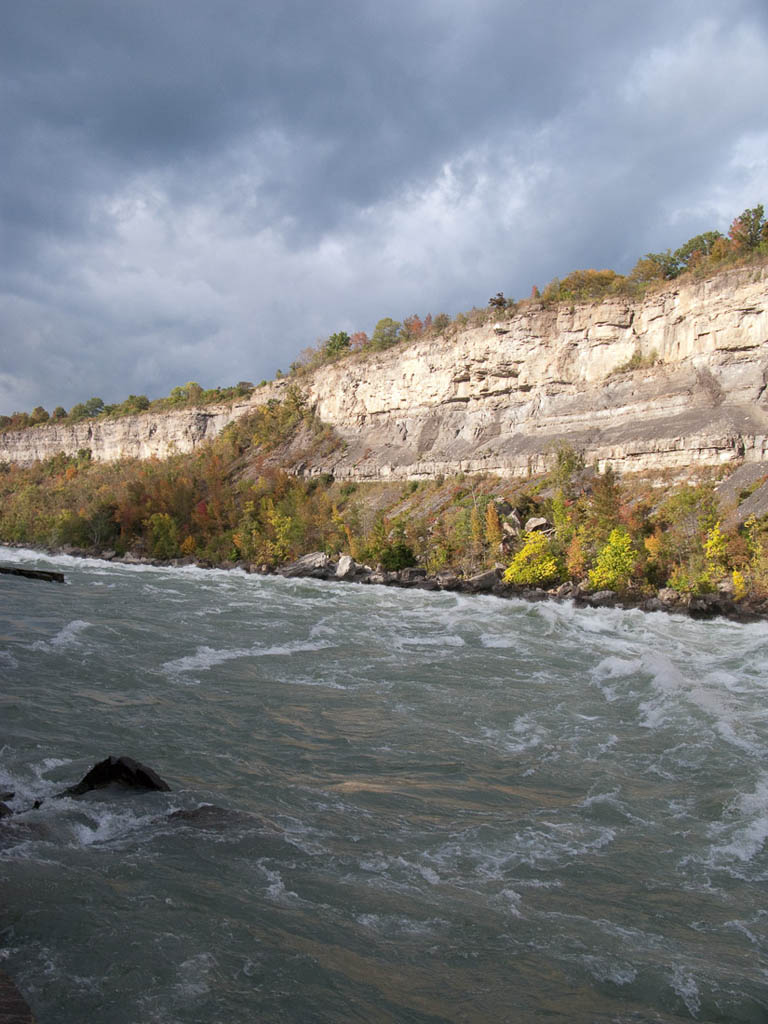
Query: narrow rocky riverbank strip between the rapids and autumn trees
4 543 768 623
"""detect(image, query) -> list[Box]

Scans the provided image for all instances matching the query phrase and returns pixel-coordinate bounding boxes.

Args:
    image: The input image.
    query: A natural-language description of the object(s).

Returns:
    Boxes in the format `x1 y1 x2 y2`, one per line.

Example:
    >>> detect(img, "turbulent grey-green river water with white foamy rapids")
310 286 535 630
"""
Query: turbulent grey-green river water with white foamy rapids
0 549 768 1024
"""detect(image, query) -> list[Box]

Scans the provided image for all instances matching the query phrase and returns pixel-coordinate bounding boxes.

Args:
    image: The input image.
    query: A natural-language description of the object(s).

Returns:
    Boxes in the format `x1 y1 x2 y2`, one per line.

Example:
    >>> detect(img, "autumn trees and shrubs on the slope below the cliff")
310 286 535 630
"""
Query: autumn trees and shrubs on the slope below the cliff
0 389 768 600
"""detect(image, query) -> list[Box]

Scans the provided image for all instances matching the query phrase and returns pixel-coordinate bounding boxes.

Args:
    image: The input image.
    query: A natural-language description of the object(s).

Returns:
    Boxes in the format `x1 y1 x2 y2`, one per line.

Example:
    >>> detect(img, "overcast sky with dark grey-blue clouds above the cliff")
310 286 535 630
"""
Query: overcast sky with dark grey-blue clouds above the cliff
0 0 768 414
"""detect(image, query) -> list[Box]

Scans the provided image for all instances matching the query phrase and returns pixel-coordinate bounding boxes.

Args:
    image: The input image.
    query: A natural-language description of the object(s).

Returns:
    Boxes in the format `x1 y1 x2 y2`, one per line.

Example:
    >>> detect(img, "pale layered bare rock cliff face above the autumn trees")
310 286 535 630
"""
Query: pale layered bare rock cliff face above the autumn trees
0 267 768 479
